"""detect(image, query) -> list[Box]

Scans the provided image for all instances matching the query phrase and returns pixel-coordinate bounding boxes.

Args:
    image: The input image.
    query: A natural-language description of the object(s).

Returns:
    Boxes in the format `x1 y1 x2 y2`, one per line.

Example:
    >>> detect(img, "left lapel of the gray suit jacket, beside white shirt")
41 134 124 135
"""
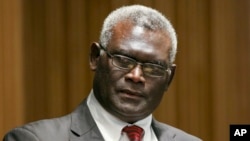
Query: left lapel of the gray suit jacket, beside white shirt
70 100 104 141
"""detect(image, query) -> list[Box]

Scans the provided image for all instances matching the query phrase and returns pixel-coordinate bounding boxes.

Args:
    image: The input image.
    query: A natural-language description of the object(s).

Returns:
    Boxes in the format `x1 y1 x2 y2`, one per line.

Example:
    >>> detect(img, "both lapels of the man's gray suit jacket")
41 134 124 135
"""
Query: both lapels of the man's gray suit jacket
70 99 176 141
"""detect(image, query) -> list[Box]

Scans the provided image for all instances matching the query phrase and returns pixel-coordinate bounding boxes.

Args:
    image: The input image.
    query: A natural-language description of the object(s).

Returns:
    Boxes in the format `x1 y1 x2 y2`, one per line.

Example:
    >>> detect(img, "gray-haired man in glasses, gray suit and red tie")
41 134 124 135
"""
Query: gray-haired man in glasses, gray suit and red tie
4 5 200 141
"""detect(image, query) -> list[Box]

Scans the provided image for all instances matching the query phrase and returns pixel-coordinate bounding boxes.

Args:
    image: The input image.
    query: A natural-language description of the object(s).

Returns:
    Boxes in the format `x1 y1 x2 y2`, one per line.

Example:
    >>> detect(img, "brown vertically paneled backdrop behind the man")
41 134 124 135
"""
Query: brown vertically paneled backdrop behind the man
0 0 250 141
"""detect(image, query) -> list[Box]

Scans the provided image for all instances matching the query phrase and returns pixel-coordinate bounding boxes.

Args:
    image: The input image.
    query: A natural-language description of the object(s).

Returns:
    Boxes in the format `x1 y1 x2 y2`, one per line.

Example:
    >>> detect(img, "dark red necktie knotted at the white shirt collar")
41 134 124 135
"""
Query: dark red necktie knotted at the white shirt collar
122 125 144 141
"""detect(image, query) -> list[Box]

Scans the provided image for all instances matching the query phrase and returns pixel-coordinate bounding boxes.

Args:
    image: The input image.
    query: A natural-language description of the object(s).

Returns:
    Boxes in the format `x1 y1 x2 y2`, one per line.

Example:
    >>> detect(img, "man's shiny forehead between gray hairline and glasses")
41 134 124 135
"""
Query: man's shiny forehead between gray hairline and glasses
109 21 171 61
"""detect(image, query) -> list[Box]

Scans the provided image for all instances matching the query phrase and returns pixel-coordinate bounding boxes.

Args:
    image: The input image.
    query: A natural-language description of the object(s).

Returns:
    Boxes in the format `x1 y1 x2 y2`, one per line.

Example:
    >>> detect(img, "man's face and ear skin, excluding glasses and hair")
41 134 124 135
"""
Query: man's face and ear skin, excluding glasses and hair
90 21 175 123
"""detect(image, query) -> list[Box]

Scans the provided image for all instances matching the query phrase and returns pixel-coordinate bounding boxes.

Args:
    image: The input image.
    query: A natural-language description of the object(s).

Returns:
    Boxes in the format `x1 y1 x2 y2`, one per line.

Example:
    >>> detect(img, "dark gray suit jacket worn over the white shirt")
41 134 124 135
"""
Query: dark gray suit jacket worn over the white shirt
3 100 200 141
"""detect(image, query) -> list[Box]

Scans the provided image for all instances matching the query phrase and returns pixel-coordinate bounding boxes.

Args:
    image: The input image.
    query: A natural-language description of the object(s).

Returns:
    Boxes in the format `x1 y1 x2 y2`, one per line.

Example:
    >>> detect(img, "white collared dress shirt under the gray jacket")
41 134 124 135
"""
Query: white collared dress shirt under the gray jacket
87 90 157 141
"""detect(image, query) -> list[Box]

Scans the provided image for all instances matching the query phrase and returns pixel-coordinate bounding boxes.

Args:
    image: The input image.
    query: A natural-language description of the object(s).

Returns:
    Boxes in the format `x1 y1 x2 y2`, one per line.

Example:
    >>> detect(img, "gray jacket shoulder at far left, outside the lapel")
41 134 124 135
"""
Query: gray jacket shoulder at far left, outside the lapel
4 115 71 141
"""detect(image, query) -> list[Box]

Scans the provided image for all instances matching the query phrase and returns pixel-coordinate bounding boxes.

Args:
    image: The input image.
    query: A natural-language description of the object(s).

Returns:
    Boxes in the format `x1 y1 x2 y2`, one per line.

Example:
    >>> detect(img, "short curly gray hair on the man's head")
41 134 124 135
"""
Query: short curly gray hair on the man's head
100 5 177 63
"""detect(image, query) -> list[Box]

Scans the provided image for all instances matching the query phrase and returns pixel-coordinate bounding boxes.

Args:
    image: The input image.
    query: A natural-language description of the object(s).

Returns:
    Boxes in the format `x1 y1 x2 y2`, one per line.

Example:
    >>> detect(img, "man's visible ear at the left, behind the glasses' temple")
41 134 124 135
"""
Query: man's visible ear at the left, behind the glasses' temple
89 42 100 71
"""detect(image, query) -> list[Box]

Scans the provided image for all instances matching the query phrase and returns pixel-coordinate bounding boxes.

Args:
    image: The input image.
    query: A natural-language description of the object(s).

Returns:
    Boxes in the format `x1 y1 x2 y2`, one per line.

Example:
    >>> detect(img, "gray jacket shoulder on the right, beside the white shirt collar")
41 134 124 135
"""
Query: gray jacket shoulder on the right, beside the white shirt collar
153 120 201 141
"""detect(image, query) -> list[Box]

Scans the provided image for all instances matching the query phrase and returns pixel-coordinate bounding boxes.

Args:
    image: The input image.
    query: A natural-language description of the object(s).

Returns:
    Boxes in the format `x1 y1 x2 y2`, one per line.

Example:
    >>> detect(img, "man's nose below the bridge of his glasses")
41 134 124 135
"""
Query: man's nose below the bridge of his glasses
125 64 145 83
